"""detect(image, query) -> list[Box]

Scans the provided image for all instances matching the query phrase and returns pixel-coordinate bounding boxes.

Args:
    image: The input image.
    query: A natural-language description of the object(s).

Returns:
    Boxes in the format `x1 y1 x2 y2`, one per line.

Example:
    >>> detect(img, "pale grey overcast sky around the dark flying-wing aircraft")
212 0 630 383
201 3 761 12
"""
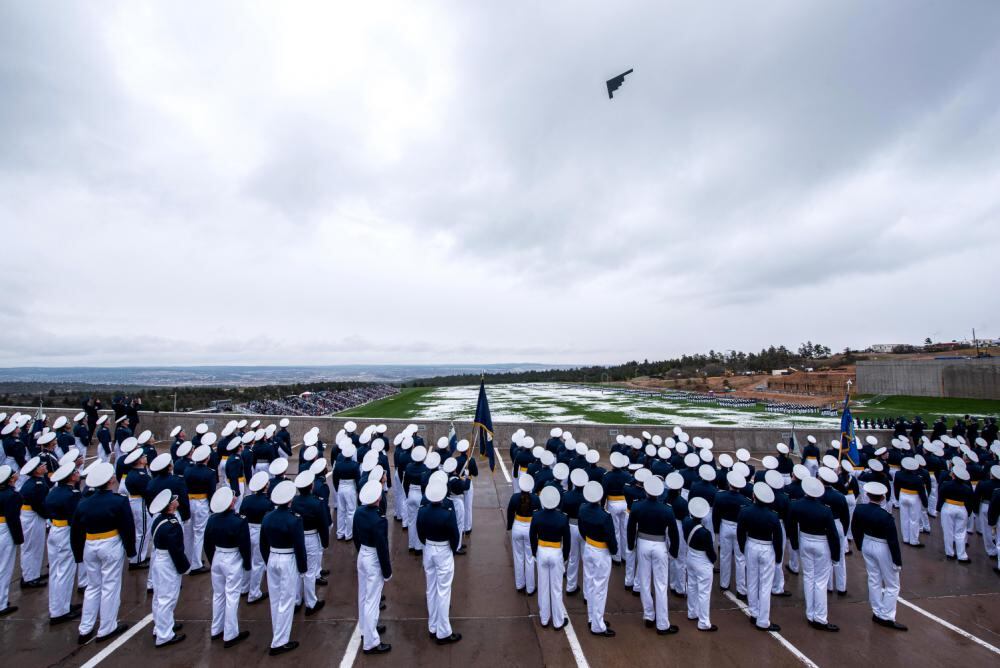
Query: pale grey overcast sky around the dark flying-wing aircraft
0 0 1000 366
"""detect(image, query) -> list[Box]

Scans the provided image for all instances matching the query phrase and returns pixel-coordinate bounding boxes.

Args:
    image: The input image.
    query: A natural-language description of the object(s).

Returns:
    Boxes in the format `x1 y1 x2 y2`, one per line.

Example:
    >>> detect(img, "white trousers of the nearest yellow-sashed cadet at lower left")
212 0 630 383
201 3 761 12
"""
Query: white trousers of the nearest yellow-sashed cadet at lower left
80 536 125 638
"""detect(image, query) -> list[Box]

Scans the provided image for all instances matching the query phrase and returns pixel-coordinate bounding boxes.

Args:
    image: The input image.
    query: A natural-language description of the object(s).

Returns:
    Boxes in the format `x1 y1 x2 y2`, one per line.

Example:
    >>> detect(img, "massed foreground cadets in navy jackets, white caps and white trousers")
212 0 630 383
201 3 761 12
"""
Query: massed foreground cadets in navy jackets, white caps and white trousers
0 411 1000 655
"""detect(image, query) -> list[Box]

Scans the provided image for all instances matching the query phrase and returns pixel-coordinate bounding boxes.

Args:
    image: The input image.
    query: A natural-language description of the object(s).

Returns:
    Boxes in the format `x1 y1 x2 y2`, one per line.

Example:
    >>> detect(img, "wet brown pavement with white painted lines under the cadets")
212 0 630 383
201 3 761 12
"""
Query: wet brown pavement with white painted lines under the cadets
0 448 1000 668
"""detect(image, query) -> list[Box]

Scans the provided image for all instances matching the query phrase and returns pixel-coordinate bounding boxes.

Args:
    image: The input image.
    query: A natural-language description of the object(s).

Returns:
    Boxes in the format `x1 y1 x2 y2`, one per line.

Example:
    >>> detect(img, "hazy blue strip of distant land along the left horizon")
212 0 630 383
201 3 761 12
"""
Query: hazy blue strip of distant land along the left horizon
0 363 573 387
